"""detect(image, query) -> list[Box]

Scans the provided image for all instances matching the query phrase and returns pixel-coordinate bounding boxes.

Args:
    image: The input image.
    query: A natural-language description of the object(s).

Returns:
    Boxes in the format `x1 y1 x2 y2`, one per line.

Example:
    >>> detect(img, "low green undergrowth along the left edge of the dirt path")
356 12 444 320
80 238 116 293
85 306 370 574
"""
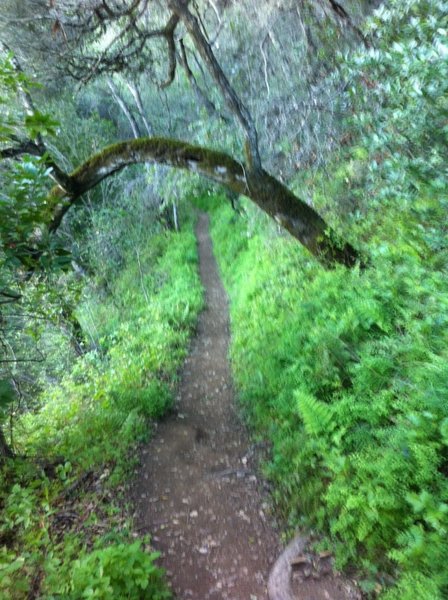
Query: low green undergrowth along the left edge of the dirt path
0 224 202 600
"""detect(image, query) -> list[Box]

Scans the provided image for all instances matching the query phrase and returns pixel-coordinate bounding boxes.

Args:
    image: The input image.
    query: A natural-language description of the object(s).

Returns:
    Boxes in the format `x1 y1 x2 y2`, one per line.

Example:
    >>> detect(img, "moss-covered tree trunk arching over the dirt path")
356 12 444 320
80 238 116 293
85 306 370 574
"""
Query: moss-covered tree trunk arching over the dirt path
49 138 359 266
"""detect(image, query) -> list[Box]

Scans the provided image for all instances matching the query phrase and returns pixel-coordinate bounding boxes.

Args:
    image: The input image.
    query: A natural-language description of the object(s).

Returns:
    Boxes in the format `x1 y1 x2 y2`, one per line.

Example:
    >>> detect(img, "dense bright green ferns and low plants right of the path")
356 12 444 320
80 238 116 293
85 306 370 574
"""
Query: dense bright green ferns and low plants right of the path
213 200 448 600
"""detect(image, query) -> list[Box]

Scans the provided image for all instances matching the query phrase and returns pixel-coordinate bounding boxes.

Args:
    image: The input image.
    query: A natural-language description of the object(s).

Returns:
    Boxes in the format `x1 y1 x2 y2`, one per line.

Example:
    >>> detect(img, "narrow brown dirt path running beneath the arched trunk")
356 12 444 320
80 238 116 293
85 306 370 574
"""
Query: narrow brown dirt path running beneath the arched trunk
137 214 278 600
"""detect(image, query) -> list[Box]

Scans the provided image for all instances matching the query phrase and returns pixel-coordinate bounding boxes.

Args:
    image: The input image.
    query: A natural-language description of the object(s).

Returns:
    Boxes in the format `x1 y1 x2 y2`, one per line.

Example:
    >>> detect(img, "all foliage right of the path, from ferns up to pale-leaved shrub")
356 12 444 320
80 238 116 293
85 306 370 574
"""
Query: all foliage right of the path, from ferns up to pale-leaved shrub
208 1 448 600
